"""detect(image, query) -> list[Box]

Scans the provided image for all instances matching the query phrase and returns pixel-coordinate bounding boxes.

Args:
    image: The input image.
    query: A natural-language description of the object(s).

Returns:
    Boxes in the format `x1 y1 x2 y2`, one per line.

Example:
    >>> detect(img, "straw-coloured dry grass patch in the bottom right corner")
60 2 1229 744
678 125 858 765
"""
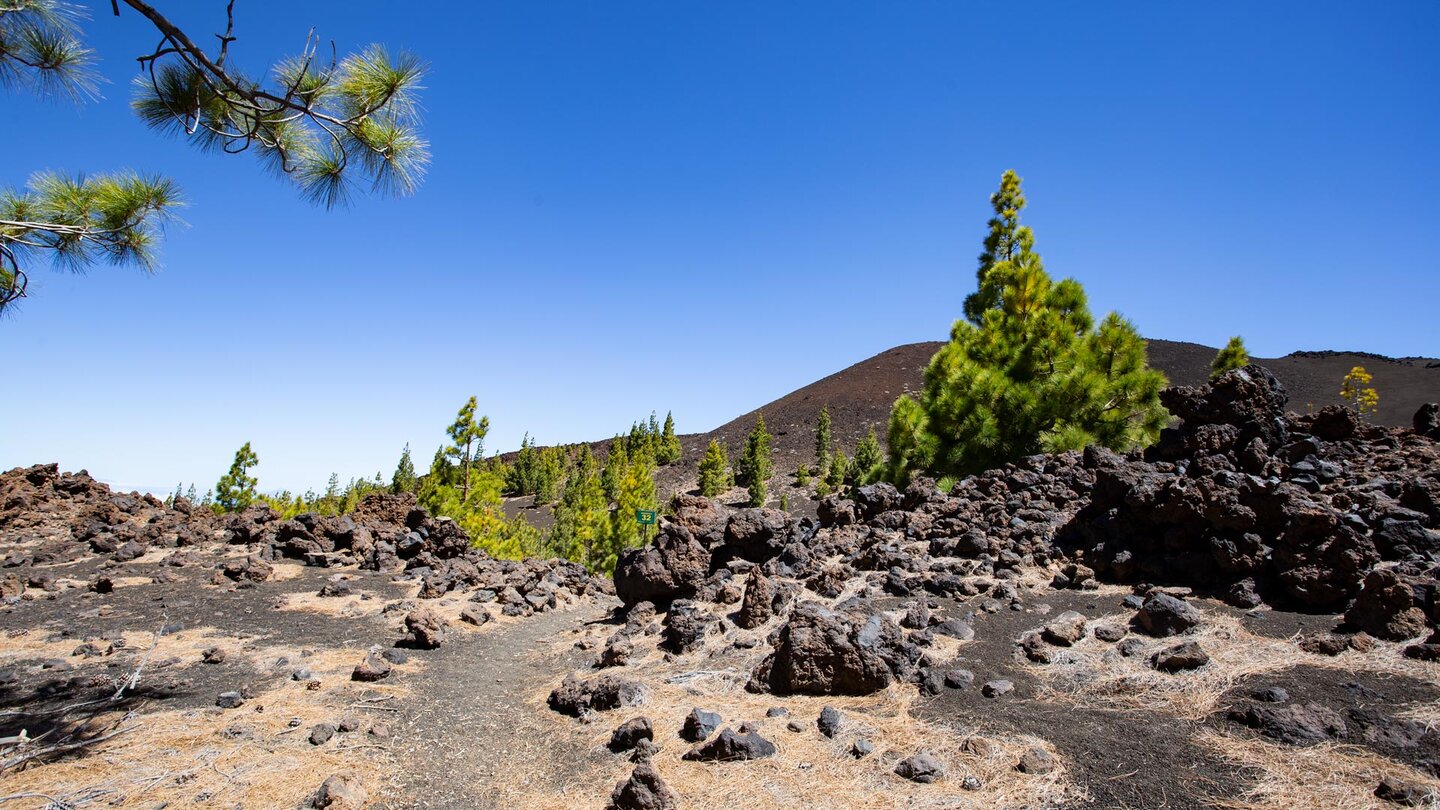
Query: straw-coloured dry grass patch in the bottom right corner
1195 731 1440 810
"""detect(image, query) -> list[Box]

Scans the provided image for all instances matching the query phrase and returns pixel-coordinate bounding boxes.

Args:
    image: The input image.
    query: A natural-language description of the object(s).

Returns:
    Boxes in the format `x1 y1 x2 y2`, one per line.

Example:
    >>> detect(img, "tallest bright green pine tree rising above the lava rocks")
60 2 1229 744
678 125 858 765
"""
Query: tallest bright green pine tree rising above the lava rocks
888 172 1169 481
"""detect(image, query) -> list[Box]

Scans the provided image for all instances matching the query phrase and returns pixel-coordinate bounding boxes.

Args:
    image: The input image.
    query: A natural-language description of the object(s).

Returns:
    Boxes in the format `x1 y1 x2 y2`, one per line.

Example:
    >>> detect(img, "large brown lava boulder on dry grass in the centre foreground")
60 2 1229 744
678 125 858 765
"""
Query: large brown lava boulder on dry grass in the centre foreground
749 602 920 695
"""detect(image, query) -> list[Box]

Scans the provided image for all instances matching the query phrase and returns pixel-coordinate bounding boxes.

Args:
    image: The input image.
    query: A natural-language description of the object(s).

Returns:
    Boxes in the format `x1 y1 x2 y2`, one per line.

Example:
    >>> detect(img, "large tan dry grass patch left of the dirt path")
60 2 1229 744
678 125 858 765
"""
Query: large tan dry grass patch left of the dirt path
3 630 419 807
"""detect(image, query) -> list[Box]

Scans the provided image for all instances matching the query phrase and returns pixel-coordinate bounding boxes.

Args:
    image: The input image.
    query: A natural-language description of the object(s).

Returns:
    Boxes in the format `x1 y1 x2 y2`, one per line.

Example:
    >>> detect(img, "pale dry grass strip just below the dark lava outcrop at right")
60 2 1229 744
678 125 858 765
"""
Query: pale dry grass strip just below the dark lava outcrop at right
1034 611 1440 719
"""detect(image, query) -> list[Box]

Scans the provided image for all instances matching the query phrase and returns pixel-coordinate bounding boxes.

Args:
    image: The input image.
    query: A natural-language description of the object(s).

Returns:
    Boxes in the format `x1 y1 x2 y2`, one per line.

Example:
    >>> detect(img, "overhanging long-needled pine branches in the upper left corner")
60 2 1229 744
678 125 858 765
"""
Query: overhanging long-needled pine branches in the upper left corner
0 0 429 314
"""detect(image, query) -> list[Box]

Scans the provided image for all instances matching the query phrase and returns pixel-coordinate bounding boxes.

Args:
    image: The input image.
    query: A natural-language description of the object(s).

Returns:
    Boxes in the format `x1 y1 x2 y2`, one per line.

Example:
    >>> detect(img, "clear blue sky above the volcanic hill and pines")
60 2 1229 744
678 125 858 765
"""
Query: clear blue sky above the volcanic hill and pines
0 0 1440 491
